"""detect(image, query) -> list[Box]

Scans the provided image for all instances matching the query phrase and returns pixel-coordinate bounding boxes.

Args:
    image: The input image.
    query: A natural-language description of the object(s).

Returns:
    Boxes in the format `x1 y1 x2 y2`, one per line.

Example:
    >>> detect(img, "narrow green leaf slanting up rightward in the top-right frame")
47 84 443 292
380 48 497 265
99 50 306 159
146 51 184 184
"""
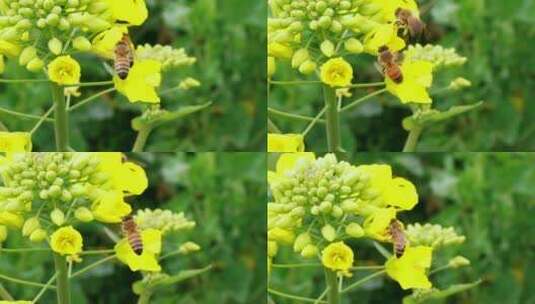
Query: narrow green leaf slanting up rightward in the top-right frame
402 101 483 131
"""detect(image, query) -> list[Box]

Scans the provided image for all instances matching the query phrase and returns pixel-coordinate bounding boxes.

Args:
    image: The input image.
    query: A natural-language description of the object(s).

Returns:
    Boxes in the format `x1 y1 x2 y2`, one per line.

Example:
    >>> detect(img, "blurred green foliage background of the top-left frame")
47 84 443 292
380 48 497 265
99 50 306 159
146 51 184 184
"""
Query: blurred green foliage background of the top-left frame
0 0 266 152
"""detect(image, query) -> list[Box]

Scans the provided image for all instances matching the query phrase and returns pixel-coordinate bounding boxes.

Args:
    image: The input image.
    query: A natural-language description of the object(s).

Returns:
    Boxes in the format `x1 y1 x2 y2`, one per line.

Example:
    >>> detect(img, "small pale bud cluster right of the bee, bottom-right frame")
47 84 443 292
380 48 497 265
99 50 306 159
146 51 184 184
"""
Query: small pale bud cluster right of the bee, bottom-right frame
405 223 466 248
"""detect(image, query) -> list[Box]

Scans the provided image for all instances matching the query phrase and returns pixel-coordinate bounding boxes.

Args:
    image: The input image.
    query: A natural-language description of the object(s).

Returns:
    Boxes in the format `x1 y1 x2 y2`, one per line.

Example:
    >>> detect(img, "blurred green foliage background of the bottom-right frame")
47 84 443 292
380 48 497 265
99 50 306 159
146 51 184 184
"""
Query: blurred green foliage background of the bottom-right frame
269 153 535 304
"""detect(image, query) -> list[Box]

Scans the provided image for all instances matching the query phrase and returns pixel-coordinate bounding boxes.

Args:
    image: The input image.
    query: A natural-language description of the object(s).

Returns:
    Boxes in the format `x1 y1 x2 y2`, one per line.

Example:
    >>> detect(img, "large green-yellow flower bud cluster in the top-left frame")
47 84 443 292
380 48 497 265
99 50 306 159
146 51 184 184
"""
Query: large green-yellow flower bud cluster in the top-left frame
0 0 113 71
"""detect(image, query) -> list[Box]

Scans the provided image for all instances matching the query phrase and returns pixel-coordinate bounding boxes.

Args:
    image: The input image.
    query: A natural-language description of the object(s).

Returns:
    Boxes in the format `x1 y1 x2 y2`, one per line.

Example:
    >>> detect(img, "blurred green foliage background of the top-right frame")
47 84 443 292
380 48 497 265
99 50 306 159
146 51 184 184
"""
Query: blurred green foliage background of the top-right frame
269 0 535 151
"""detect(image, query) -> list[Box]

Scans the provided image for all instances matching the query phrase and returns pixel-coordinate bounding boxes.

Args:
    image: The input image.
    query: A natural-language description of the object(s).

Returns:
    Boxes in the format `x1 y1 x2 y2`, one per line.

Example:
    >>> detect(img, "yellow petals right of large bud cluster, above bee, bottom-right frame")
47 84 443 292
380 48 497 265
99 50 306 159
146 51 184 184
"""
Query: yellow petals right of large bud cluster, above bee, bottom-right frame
358 165 418 210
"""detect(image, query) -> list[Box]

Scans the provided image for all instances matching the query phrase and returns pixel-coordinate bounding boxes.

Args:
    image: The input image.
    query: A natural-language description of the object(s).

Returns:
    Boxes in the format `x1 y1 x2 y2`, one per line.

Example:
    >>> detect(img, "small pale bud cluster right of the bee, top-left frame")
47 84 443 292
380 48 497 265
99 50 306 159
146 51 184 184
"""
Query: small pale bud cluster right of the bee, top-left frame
136 44 197 70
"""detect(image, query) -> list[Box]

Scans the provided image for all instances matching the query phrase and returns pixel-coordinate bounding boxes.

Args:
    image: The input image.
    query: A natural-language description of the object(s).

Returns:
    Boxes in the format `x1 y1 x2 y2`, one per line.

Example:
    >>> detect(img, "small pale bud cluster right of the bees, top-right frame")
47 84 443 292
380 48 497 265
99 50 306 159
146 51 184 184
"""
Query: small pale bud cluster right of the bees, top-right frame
403 44 467 69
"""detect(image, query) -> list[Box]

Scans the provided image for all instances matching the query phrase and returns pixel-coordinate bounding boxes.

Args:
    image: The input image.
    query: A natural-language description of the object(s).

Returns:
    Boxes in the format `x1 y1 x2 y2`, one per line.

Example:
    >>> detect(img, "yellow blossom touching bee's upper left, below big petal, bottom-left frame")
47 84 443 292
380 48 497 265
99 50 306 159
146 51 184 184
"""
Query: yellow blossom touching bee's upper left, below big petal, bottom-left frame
91 189 132 223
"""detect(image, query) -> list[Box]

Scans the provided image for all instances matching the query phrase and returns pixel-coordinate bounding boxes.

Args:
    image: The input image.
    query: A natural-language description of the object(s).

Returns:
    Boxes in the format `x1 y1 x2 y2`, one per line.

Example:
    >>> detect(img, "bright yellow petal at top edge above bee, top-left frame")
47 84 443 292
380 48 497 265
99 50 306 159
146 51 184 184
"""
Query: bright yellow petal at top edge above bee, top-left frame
106 0 149 25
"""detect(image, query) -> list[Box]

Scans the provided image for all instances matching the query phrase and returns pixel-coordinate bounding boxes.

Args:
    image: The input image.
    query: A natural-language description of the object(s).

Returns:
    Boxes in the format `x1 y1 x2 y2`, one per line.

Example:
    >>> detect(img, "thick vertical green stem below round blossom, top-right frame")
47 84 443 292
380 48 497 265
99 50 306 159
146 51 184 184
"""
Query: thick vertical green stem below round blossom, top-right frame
323 85 343 153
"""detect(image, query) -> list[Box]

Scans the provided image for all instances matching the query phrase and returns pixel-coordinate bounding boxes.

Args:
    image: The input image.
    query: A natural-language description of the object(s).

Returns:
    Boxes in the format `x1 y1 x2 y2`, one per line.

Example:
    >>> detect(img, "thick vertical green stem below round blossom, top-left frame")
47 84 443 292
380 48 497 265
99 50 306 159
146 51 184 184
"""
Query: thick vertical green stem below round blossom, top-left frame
51 83 69 152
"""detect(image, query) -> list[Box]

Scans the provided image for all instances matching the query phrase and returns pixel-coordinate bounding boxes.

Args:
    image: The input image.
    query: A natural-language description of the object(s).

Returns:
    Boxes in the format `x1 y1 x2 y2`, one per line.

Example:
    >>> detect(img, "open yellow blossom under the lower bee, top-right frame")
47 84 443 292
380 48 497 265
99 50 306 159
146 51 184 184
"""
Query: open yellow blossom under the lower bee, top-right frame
385 61 433 103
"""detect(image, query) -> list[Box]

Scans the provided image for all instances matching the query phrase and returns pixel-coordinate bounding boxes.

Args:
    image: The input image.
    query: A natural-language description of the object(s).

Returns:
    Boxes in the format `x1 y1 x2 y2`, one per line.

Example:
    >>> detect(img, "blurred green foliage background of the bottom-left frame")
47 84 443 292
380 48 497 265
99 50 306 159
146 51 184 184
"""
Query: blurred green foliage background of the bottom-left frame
0 152 266 304
